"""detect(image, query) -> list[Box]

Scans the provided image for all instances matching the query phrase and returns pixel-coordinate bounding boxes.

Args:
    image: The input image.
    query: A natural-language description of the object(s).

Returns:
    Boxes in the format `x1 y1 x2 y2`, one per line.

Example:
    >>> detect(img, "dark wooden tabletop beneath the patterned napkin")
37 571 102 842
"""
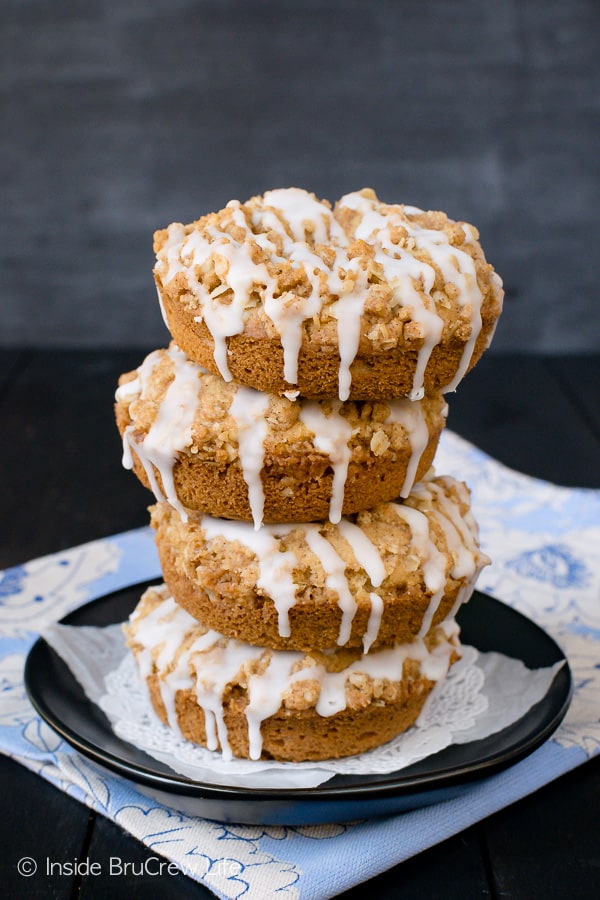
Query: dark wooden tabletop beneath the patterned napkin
0 350 600 900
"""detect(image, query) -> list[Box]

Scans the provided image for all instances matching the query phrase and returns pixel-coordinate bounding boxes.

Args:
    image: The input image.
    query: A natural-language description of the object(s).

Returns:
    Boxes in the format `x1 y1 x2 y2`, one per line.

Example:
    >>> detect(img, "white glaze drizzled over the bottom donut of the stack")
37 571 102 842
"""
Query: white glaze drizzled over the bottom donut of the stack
130 597 458 759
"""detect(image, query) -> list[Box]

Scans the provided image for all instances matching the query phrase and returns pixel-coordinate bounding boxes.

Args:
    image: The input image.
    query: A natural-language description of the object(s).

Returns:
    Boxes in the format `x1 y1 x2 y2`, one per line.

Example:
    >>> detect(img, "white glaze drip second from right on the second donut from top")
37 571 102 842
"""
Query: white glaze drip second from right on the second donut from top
300 400 352 523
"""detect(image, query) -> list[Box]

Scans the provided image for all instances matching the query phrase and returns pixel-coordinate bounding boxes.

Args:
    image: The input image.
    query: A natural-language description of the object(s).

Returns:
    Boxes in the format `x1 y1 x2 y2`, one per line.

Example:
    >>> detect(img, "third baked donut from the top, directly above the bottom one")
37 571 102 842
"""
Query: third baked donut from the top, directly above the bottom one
150 477 488 652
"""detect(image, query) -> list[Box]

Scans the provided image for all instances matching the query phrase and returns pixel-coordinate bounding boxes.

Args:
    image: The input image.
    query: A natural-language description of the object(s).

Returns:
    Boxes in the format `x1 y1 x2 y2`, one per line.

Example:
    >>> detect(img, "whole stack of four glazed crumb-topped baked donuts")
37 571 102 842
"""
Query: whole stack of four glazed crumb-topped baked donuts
115 188 503 761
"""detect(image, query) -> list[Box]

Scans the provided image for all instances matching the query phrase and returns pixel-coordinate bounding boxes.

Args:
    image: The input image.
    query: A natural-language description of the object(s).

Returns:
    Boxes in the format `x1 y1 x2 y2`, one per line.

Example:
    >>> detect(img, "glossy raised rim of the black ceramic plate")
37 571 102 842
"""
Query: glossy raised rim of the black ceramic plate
24 579 573 804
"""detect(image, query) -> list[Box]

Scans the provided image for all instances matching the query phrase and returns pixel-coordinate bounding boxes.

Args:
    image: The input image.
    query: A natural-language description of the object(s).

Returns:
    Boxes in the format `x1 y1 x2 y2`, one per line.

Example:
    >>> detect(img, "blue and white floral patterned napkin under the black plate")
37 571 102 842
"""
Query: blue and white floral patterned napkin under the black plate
0 431 600 900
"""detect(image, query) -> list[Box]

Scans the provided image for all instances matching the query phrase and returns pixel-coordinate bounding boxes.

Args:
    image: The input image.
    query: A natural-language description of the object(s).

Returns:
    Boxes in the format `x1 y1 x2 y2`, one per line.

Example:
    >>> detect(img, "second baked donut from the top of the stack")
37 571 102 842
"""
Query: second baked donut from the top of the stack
116 344 447 527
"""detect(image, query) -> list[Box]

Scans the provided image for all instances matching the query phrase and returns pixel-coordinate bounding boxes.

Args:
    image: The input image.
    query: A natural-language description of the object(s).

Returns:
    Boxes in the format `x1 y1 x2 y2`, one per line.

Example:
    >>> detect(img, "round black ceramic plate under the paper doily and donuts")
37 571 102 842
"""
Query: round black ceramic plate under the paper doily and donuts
25 585 572 825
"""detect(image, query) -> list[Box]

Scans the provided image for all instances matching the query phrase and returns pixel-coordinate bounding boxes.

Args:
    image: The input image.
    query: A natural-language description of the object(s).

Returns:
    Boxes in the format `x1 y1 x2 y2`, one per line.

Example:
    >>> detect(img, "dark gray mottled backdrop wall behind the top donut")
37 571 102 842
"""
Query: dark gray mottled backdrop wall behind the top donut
0 0 600 352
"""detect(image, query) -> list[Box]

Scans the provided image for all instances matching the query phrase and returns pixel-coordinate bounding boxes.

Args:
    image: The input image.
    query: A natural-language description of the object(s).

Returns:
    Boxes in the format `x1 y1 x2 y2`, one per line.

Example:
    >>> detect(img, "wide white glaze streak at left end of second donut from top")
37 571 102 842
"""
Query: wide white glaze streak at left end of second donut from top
115 346 198 520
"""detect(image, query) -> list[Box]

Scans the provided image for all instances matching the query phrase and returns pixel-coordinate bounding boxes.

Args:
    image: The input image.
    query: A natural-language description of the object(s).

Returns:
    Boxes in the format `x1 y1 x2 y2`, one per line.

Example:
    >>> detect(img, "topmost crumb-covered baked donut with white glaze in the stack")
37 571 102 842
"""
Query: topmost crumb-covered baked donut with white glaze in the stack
154 188 503 400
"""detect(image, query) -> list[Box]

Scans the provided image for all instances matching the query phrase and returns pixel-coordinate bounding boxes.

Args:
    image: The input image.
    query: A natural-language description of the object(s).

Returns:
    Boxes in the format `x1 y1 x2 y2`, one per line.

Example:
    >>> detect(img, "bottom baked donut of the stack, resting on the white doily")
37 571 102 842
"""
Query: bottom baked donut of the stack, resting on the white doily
125 585 460 762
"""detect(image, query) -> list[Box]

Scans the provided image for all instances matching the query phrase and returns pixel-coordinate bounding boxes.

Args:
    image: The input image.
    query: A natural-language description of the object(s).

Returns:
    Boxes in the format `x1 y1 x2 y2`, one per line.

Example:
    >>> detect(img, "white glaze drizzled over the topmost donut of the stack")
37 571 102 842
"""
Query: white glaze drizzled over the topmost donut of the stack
157 188 490 400
